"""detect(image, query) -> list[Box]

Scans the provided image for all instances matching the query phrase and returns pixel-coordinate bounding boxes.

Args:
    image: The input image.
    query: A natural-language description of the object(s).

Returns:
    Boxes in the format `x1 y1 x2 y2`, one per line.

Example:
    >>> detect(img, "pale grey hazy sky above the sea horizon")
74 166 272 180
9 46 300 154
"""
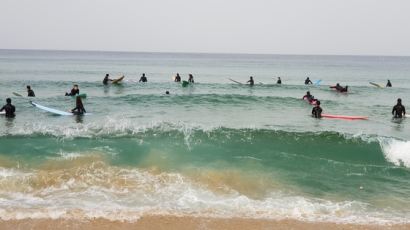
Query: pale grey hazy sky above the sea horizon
0 0 410 55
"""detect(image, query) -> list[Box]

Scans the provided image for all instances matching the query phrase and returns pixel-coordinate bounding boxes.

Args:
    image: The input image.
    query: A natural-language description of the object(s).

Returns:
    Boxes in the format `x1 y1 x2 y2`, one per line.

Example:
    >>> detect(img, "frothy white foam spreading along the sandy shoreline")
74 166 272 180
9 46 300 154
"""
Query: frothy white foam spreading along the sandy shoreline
0 167 410 224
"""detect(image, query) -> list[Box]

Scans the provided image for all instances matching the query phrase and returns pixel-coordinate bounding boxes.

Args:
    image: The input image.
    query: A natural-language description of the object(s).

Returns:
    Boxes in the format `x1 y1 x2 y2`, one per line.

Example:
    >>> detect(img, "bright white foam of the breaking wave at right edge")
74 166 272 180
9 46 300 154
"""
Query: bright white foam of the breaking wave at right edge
380 139 410 168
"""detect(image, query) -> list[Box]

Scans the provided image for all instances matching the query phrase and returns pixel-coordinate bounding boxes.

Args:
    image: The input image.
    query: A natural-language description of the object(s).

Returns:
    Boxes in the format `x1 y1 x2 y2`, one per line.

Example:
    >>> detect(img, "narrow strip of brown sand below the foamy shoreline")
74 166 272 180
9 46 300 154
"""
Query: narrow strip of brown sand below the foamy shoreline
0 216 410 230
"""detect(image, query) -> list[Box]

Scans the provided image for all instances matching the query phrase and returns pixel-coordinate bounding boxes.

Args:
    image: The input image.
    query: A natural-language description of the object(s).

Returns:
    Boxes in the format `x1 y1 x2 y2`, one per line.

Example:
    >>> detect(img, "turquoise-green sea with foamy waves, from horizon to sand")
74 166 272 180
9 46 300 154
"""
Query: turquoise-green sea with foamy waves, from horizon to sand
0 50 410 224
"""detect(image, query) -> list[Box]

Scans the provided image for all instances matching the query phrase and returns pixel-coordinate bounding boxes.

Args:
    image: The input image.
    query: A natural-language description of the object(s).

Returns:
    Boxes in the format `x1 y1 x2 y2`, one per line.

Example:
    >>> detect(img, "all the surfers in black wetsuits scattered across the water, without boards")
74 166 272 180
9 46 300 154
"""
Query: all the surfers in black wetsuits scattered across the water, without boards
0 73 406 118
